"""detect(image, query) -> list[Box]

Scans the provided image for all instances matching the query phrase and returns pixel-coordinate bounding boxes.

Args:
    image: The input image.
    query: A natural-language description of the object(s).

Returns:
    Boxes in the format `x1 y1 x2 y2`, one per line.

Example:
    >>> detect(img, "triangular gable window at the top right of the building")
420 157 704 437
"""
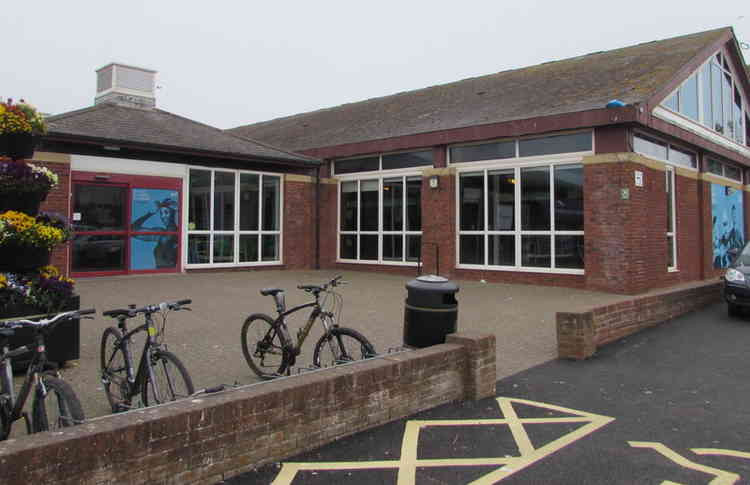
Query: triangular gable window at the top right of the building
663 52 750 146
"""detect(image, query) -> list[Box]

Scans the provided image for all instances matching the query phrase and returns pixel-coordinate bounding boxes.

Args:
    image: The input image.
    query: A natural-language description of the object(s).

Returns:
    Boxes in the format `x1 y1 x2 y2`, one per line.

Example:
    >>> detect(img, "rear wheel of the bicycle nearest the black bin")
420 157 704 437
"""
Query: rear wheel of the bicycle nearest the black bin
242 313 289 379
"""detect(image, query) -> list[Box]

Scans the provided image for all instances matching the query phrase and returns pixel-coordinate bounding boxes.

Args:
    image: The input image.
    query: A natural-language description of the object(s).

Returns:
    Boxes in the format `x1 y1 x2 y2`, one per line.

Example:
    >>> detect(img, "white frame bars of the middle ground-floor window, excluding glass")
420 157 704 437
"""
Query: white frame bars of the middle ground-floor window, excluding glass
336 166 430 267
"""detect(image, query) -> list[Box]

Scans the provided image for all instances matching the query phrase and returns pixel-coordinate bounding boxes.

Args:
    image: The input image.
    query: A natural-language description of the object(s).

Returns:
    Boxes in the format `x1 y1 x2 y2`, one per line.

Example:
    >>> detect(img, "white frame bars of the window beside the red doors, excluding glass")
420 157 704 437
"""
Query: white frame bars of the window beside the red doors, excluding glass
183 165 284 269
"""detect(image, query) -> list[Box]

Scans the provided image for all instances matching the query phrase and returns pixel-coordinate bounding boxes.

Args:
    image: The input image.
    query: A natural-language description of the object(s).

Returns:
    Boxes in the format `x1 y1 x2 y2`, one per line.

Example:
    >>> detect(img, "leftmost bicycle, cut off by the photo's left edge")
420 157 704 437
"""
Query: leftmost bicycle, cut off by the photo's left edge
0 308 96 441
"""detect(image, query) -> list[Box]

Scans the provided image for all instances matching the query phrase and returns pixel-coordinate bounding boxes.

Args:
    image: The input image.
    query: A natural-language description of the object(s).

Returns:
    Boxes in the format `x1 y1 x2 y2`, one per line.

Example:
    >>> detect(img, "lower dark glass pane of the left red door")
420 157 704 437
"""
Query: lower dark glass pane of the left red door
72 234 125 272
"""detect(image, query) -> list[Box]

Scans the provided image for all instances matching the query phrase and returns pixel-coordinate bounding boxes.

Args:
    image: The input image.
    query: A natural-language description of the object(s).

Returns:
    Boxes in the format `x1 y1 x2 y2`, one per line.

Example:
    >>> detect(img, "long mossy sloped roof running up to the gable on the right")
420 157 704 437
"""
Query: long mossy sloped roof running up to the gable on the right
228 27 731 151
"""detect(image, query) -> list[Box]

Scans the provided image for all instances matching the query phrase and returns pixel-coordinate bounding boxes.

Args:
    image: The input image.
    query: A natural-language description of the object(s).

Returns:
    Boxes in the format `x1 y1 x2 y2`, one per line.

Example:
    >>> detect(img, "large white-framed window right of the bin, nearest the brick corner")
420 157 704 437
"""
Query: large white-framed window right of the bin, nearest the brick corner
457 163 584 273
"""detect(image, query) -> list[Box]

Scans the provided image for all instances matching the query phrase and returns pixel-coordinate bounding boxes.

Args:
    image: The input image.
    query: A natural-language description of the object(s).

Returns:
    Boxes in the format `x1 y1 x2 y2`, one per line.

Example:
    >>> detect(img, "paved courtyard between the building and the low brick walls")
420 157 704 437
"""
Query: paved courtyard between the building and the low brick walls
53 270 627 418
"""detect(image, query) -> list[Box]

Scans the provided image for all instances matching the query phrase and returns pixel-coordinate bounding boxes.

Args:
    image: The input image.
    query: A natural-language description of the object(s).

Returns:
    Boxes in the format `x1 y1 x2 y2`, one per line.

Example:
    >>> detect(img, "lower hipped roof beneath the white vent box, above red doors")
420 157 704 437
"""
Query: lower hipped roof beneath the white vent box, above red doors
47 103 317 164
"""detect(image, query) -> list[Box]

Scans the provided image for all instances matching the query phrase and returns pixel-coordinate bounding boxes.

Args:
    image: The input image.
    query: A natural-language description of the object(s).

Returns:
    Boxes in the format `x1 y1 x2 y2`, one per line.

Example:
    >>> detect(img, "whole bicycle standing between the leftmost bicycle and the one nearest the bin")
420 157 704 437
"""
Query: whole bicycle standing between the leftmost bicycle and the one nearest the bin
101 300 195 413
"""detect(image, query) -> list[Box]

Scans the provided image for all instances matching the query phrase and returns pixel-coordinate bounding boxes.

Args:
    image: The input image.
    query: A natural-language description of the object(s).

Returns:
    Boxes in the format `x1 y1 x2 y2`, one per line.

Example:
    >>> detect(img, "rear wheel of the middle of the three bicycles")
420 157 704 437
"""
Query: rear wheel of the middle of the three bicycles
101 327 130 413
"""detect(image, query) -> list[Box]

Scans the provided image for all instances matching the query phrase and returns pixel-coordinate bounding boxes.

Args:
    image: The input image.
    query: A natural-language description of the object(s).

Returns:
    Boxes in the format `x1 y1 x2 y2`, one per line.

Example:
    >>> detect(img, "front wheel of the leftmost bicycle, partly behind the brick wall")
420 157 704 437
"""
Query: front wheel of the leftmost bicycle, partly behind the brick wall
31 374 84 433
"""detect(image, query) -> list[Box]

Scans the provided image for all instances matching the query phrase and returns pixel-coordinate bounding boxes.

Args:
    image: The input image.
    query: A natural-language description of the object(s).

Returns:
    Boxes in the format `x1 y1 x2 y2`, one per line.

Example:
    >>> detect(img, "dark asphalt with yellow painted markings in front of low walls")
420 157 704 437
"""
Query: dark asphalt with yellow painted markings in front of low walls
235 305 750 485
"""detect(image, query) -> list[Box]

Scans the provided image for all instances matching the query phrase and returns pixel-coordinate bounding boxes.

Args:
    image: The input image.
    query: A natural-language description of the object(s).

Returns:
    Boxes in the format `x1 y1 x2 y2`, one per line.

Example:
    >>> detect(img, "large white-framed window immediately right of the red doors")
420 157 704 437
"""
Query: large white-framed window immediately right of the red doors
188 168 281 266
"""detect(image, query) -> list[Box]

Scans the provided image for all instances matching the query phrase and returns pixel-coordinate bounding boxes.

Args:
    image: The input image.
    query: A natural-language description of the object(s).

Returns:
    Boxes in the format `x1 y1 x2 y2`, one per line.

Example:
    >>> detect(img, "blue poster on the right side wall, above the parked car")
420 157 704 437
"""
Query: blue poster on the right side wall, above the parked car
711 184 745 268
